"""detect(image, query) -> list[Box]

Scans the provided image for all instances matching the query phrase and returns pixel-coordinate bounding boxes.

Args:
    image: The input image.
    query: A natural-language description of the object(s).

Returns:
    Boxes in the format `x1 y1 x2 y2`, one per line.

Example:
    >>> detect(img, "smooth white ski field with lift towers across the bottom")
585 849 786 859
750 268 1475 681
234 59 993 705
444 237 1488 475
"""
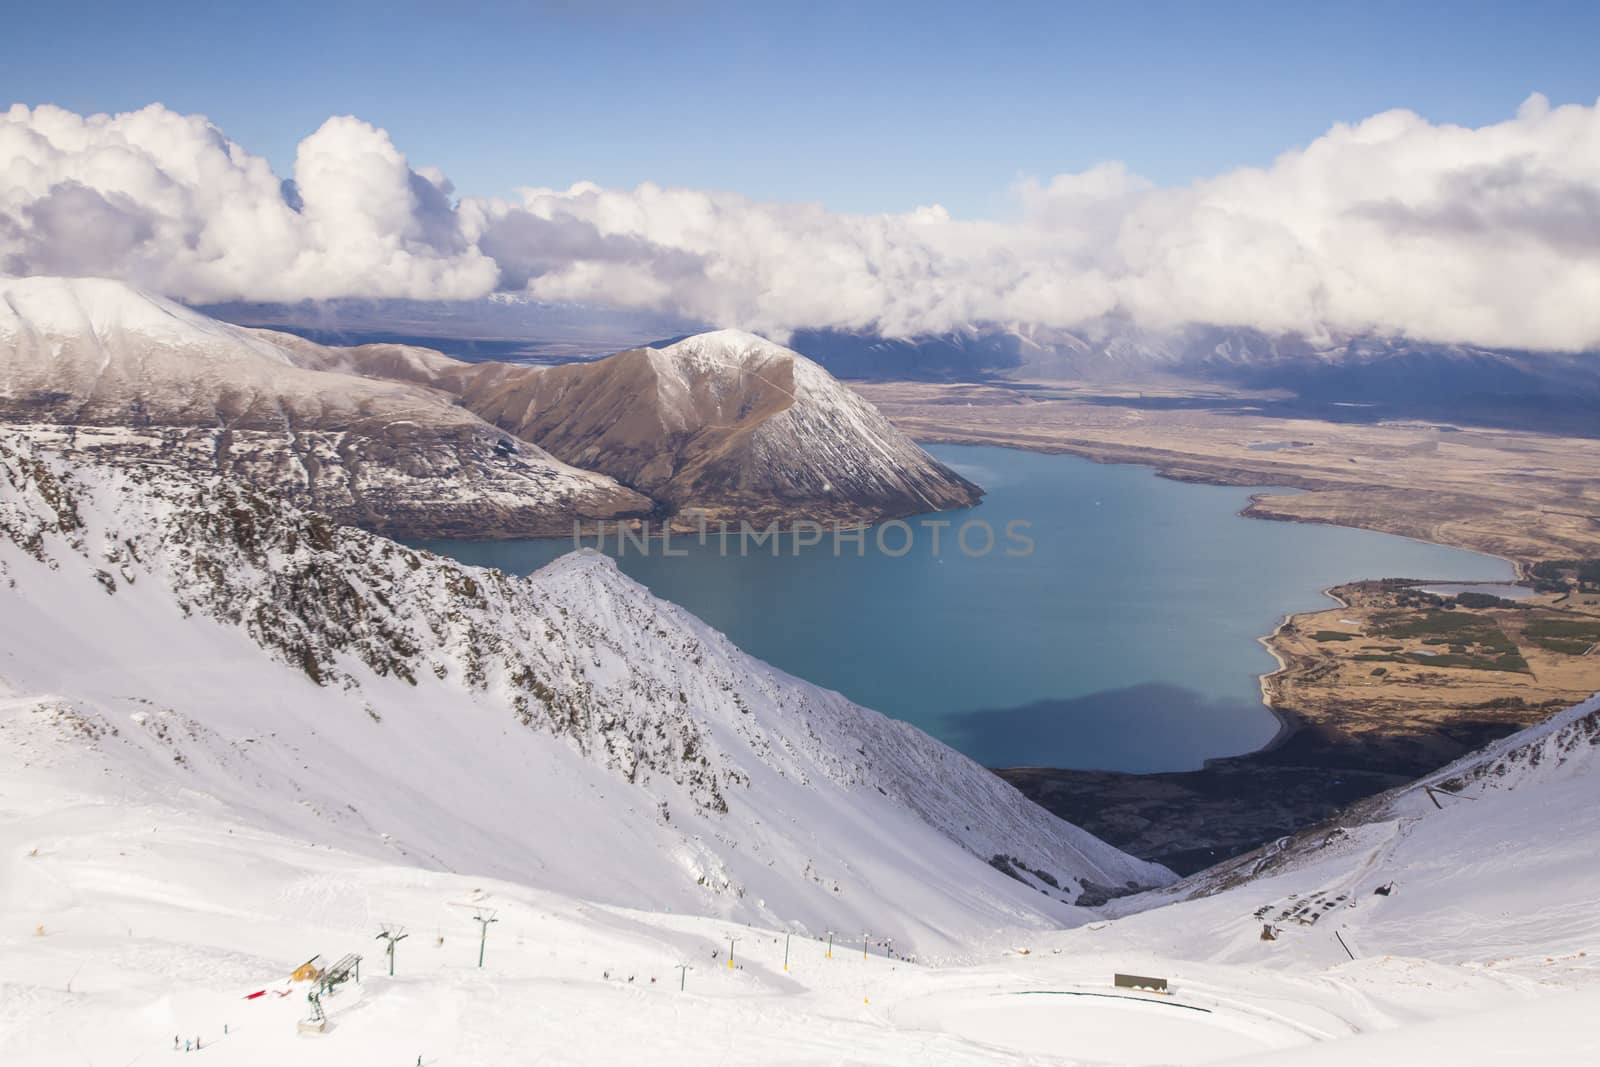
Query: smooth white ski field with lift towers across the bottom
0 691 1600 1067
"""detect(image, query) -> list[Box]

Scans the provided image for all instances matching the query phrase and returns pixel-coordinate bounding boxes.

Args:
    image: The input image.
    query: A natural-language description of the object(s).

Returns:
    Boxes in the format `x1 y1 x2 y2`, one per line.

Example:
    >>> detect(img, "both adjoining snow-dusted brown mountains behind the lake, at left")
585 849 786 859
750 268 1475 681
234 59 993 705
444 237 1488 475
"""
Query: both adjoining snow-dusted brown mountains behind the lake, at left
0 278 981 537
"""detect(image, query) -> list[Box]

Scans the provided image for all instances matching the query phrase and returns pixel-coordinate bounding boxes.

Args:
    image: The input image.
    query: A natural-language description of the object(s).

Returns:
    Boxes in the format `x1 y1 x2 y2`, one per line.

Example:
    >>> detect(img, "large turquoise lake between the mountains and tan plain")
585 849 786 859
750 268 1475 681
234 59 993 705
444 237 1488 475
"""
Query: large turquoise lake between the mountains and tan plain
418 445 1514 771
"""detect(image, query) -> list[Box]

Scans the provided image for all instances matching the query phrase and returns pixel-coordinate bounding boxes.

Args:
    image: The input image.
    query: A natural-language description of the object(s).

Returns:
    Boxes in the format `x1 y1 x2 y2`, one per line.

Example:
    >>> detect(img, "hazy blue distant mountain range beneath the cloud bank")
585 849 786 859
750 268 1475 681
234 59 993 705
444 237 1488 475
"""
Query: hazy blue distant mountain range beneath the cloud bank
213 301 1600 435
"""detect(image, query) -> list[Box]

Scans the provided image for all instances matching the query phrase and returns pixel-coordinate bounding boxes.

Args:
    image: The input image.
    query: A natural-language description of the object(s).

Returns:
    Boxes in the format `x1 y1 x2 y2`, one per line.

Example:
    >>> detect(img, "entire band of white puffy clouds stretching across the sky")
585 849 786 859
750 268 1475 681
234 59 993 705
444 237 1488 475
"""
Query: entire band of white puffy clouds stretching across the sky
0 96 1600 350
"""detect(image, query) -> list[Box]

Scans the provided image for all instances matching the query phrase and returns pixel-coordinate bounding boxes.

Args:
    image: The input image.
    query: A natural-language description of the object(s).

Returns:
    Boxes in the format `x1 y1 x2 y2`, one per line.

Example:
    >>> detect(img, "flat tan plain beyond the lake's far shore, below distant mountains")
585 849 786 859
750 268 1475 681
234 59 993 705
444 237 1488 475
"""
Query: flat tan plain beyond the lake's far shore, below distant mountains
853 381 1600 574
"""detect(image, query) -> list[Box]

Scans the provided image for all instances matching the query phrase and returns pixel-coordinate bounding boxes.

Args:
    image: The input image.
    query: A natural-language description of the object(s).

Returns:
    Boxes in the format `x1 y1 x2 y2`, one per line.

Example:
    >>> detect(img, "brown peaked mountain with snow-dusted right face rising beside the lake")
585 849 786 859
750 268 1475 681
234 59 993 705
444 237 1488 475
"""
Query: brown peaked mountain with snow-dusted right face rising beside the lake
294 330 981 522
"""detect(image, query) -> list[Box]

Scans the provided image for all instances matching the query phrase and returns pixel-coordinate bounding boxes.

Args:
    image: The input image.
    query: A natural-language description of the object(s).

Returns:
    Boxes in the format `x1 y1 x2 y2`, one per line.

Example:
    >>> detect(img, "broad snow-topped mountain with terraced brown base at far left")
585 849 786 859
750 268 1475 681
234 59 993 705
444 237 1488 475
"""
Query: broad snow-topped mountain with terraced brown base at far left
0 278 651 536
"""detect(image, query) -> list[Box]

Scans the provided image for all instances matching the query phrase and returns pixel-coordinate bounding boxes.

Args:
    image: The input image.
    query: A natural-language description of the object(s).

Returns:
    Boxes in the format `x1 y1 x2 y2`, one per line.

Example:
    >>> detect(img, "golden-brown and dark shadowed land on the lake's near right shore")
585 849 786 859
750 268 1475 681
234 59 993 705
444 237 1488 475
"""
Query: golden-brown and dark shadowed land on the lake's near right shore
997 582 1600 873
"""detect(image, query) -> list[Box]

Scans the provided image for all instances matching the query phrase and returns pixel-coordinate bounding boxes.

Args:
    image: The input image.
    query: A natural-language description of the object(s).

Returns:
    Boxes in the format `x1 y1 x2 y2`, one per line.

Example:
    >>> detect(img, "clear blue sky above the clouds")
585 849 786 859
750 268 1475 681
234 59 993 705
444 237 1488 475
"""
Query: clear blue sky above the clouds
0 0 1600 216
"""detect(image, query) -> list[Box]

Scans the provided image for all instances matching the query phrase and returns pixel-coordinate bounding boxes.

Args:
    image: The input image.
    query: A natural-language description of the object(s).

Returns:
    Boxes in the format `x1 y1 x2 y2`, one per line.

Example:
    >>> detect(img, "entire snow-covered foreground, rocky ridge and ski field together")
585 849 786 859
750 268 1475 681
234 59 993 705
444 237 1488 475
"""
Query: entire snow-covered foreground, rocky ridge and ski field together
0 437 1600 1067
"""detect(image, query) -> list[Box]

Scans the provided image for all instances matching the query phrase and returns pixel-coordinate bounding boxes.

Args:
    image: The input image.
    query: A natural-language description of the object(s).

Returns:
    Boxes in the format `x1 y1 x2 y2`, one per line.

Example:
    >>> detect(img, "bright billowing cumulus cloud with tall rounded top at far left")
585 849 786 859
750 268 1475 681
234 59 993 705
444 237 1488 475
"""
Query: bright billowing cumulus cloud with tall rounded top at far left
0 106 498 301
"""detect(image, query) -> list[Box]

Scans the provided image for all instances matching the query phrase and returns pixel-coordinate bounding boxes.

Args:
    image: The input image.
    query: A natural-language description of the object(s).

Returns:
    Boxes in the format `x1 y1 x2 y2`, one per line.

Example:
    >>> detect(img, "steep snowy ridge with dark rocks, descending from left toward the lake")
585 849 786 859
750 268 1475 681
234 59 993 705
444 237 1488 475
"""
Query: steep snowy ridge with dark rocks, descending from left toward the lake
0 435 1170 953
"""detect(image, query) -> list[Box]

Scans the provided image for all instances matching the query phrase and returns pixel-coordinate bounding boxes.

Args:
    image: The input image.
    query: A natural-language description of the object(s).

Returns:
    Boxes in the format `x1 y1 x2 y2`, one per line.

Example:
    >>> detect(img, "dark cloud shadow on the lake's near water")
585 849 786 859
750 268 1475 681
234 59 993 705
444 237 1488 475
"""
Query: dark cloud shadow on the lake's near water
941 681 1272 773
